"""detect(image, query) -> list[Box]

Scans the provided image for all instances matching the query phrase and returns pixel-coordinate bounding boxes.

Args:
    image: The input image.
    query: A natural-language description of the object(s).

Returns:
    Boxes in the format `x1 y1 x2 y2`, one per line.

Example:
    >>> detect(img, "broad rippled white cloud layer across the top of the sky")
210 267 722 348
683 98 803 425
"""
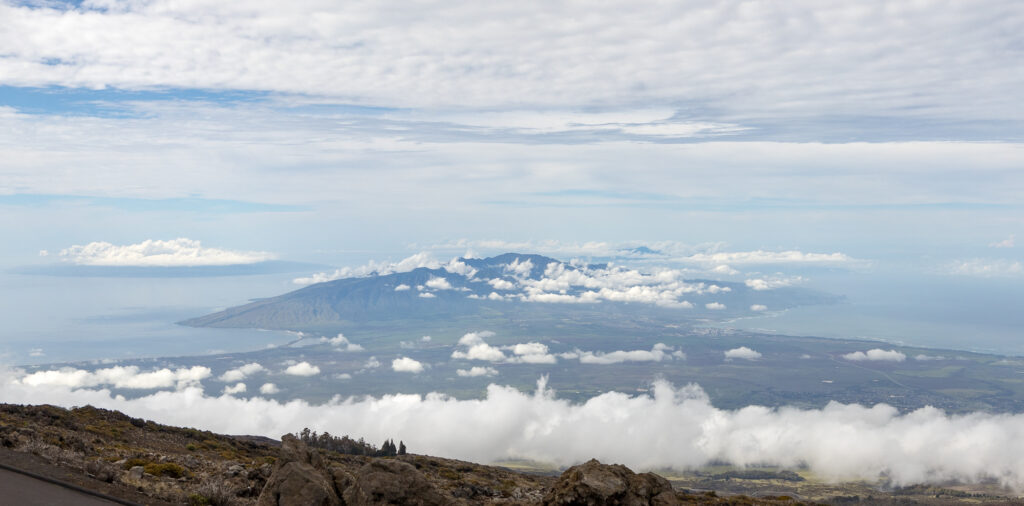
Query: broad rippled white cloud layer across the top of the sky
0 0 1018 125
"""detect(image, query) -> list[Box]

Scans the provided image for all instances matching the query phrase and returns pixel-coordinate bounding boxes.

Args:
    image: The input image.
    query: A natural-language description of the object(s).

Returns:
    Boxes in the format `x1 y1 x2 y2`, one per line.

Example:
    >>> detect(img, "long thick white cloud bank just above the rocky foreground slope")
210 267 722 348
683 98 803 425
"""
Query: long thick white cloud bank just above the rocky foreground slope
8 374 1024 491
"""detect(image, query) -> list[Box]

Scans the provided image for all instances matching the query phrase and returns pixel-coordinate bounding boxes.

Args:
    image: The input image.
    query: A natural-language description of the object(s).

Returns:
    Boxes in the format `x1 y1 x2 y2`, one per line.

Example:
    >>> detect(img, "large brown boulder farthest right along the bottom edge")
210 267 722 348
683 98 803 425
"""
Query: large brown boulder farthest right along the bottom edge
543 460 681 506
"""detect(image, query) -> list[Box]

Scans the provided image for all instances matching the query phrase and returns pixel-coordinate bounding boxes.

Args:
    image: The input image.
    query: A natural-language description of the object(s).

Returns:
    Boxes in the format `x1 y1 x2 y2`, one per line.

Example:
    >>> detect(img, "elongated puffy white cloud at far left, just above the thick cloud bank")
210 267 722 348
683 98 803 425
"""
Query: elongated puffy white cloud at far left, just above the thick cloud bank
19 366 211 389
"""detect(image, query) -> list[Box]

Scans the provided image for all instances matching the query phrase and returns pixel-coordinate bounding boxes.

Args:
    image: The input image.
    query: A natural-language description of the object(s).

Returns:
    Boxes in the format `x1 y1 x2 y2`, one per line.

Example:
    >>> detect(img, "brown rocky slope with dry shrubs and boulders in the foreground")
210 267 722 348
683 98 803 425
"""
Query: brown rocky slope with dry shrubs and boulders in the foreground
0 405 1020 506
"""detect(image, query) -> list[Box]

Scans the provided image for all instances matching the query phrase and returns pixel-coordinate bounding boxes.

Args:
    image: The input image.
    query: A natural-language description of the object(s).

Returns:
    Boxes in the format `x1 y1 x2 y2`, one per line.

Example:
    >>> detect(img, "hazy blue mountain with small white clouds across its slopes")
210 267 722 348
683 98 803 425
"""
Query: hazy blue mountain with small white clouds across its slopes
180 253 834 330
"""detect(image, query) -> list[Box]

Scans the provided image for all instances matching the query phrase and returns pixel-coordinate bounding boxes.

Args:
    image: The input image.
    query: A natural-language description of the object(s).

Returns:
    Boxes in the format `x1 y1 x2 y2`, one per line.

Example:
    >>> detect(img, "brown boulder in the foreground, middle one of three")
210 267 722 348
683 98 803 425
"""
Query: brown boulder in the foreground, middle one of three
335 459 450 506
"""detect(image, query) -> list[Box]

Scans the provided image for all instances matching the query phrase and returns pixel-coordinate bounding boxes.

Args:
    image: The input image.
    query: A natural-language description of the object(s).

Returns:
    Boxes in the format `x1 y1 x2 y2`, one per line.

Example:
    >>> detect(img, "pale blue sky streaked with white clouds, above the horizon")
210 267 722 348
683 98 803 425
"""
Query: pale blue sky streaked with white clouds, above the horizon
0 0 1024 281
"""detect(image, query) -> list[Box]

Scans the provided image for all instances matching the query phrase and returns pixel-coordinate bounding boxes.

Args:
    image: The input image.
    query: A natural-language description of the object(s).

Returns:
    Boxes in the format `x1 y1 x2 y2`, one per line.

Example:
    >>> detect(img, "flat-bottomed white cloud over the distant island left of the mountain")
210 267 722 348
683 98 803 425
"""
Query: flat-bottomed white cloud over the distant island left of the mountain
60 238 274 267
